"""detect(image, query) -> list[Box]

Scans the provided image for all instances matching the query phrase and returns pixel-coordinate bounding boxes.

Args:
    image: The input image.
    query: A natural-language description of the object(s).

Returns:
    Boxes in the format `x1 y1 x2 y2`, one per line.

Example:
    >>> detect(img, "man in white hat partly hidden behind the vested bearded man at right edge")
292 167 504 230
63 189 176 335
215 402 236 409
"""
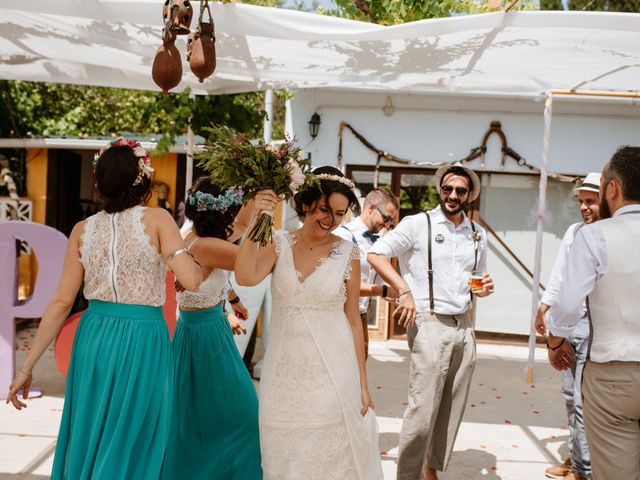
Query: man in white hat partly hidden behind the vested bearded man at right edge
535 173 600 480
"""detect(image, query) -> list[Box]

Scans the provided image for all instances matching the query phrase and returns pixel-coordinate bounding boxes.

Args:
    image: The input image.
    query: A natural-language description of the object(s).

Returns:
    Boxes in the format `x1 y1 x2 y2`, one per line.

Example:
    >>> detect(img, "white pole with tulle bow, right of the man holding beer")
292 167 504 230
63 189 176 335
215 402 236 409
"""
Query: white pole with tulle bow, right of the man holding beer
527 92 553 383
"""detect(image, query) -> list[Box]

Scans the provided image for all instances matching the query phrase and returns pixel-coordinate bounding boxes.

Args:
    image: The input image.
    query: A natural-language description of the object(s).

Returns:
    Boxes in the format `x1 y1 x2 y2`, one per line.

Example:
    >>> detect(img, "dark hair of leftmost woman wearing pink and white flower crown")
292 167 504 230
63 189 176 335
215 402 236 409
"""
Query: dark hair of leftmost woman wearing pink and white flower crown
94 145 151 213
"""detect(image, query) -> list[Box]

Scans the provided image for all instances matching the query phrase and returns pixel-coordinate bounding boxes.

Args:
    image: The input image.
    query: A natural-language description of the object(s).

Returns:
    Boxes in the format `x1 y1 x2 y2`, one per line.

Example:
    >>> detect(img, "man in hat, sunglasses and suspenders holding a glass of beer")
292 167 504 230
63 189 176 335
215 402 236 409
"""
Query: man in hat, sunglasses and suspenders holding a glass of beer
367 163 493 480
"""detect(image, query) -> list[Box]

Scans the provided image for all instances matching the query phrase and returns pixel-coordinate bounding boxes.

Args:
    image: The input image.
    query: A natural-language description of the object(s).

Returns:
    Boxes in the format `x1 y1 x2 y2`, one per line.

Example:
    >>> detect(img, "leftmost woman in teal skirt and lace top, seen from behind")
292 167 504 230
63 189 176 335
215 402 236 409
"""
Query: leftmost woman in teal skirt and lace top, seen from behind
8 139 203 480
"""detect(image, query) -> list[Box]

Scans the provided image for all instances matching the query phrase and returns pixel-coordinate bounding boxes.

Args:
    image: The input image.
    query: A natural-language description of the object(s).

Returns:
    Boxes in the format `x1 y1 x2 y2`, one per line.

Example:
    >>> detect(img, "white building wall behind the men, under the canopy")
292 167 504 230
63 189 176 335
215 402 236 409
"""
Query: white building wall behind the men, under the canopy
290 90 640 334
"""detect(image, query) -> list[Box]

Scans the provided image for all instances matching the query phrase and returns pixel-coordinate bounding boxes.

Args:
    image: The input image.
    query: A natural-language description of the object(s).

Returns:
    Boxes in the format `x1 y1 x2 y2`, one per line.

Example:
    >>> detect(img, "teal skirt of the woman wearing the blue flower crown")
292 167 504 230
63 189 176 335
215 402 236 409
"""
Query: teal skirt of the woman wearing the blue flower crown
163 305 262 480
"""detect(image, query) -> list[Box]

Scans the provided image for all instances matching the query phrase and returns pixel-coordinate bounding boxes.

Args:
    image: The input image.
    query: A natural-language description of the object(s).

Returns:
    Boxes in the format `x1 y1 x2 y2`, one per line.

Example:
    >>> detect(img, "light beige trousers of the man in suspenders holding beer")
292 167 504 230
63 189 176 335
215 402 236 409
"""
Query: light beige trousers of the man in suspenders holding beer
397 313 476 480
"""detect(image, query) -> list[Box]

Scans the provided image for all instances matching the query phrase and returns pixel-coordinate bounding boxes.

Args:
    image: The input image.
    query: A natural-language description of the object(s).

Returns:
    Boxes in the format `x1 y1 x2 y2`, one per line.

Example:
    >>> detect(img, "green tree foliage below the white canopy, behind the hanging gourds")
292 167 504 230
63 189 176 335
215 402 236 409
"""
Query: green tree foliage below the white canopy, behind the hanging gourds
0 80 264 150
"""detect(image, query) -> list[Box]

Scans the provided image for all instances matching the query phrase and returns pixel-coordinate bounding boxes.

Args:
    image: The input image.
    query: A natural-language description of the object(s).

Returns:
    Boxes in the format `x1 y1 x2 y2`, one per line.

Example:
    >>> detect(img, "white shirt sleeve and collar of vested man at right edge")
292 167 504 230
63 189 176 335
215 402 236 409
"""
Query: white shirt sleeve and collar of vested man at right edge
547 205 640 337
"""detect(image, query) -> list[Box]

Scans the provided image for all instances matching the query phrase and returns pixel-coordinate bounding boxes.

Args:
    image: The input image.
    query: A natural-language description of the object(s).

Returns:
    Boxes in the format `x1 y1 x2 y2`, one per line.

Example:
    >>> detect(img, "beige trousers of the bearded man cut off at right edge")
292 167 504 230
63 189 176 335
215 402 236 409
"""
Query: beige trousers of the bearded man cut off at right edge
582 360 640 480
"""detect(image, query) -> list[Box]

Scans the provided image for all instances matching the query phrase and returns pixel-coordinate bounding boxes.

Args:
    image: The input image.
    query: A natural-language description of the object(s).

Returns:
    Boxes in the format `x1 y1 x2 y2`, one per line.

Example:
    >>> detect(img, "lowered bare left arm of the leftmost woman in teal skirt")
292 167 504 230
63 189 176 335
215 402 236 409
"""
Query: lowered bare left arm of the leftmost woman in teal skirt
7 222 84 410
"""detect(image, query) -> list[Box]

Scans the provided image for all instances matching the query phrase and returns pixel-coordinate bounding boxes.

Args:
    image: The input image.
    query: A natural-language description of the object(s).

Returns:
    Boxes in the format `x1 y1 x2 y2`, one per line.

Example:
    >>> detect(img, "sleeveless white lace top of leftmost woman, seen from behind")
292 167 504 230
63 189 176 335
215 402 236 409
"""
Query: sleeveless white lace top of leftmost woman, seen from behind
80 206 167 306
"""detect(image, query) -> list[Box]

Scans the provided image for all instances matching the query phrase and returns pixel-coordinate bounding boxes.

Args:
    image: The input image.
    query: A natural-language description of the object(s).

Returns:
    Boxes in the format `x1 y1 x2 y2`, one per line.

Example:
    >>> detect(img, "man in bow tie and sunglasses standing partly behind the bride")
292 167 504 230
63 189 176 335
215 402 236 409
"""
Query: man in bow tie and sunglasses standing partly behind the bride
333 187 399 360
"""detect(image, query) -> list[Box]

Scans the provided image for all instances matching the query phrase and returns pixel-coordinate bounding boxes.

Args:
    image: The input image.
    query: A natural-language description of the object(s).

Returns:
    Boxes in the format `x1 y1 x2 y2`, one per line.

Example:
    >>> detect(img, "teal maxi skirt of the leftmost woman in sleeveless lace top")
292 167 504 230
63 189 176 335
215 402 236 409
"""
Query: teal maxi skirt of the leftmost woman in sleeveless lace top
51 300 173 480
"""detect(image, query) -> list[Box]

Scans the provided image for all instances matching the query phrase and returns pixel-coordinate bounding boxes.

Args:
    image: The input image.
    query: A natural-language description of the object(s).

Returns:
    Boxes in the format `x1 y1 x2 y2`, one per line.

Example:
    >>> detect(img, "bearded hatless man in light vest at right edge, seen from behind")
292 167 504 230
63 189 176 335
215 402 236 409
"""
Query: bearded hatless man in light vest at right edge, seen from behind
547 146 640 480
